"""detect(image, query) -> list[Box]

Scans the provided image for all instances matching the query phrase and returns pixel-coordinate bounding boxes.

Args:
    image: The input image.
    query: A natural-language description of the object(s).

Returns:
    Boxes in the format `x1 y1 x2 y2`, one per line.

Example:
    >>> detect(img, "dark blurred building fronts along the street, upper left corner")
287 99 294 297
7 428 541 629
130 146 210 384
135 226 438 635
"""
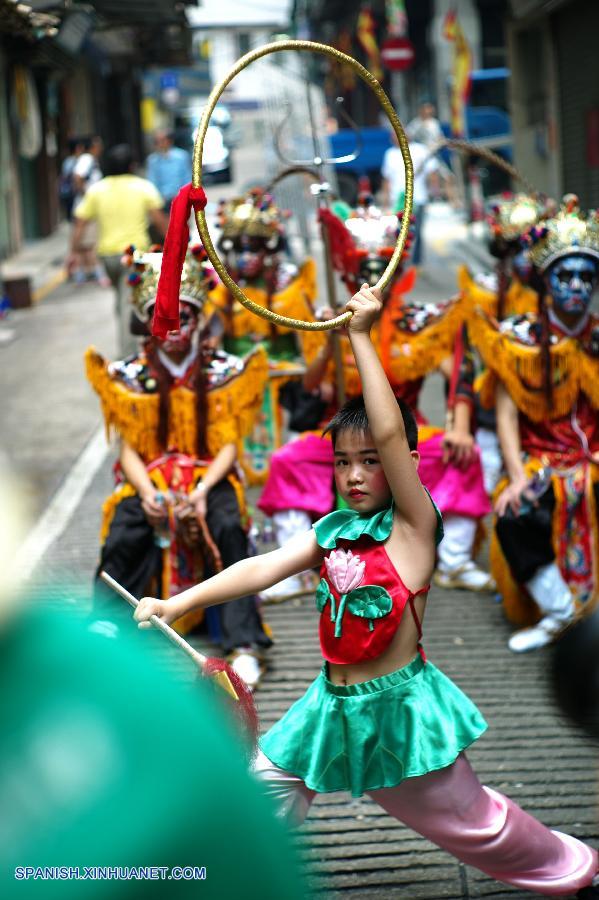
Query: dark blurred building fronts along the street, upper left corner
0 0 196 260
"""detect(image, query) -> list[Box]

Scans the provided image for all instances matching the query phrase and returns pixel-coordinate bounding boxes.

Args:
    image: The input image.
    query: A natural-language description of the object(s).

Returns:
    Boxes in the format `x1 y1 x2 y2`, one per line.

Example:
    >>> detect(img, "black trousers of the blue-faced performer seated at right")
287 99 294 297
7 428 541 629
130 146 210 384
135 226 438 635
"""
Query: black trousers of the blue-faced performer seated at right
495 484 599 584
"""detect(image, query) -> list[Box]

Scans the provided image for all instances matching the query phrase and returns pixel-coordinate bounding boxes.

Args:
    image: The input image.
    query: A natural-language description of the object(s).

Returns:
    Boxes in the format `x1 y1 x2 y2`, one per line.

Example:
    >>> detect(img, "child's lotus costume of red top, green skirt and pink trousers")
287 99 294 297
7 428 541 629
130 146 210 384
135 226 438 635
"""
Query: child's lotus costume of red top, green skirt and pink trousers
255 508 598 896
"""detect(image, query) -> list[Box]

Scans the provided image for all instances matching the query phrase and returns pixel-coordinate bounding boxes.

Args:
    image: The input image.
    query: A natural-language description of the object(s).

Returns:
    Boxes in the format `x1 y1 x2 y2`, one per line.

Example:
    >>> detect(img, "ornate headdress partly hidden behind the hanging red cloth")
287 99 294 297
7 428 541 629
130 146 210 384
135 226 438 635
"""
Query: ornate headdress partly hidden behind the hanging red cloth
123 244 217 322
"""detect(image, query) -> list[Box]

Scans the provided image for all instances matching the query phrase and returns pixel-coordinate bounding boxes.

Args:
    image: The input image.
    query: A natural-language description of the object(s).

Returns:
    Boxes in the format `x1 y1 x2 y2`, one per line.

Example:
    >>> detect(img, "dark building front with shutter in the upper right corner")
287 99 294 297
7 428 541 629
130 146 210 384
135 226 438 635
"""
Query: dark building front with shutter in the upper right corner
507 0 599 207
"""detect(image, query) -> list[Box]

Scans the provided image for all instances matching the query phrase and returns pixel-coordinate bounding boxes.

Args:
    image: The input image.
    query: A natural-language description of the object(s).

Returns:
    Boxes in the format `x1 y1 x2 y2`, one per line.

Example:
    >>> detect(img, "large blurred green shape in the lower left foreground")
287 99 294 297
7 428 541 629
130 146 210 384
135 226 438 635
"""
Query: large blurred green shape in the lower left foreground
0 607 307 900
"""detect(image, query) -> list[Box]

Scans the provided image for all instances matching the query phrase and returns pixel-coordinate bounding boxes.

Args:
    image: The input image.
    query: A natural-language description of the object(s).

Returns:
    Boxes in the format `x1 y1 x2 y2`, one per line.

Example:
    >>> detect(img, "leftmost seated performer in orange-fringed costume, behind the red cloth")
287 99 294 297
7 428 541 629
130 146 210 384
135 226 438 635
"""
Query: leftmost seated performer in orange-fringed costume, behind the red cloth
86 245 271 686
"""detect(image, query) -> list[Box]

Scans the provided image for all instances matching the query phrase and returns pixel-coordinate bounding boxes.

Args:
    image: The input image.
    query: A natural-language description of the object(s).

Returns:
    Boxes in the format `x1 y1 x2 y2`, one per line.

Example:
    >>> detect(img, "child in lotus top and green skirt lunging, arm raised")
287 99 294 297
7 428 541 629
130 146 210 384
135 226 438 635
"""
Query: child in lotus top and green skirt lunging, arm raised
135 285 599 900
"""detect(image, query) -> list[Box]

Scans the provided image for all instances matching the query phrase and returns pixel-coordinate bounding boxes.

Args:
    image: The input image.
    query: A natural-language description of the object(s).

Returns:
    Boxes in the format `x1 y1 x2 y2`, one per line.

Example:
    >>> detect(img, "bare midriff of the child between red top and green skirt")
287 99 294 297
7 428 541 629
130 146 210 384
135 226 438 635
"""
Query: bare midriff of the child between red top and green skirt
328 597 426 685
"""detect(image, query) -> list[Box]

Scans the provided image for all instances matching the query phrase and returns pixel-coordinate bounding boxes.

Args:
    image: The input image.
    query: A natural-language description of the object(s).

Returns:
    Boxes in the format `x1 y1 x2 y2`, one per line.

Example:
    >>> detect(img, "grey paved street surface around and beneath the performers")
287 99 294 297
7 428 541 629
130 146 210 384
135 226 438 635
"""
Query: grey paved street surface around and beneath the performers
0 144 599 900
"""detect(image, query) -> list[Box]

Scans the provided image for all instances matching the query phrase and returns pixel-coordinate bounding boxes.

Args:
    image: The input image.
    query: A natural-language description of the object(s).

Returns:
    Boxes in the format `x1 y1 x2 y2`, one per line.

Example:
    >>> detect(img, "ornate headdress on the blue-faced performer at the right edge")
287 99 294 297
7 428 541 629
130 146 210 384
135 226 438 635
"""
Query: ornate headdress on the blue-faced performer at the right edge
526 194 599 273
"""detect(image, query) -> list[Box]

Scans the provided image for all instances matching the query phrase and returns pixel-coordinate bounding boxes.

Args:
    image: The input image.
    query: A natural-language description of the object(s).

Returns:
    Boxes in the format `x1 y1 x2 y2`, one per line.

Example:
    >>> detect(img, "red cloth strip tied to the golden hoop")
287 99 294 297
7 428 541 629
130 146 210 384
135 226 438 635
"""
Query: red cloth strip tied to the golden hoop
152 184 206 339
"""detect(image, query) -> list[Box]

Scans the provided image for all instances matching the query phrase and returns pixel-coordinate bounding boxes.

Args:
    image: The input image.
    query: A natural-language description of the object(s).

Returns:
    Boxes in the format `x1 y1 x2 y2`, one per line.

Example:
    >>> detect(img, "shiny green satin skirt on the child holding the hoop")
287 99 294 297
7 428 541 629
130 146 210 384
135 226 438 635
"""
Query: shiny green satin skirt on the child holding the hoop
260 656 487 797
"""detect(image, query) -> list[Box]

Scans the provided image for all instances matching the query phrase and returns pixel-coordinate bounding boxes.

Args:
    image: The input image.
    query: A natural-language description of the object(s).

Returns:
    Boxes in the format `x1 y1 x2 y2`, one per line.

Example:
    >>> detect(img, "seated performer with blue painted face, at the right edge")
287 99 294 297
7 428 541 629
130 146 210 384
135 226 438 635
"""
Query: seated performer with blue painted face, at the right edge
470 195 599 652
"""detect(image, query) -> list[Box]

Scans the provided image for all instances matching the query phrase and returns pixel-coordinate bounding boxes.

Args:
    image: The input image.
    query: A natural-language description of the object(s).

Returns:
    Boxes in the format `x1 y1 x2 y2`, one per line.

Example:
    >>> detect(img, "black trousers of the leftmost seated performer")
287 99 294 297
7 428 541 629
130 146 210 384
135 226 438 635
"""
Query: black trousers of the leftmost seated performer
94 479 272 653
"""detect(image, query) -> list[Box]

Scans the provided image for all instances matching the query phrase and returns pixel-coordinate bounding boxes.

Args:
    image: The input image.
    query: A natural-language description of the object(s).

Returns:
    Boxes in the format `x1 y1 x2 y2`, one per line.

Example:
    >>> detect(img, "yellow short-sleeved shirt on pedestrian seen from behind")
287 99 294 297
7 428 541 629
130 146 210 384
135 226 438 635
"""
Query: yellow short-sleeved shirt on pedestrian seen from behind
75 175 164 256
